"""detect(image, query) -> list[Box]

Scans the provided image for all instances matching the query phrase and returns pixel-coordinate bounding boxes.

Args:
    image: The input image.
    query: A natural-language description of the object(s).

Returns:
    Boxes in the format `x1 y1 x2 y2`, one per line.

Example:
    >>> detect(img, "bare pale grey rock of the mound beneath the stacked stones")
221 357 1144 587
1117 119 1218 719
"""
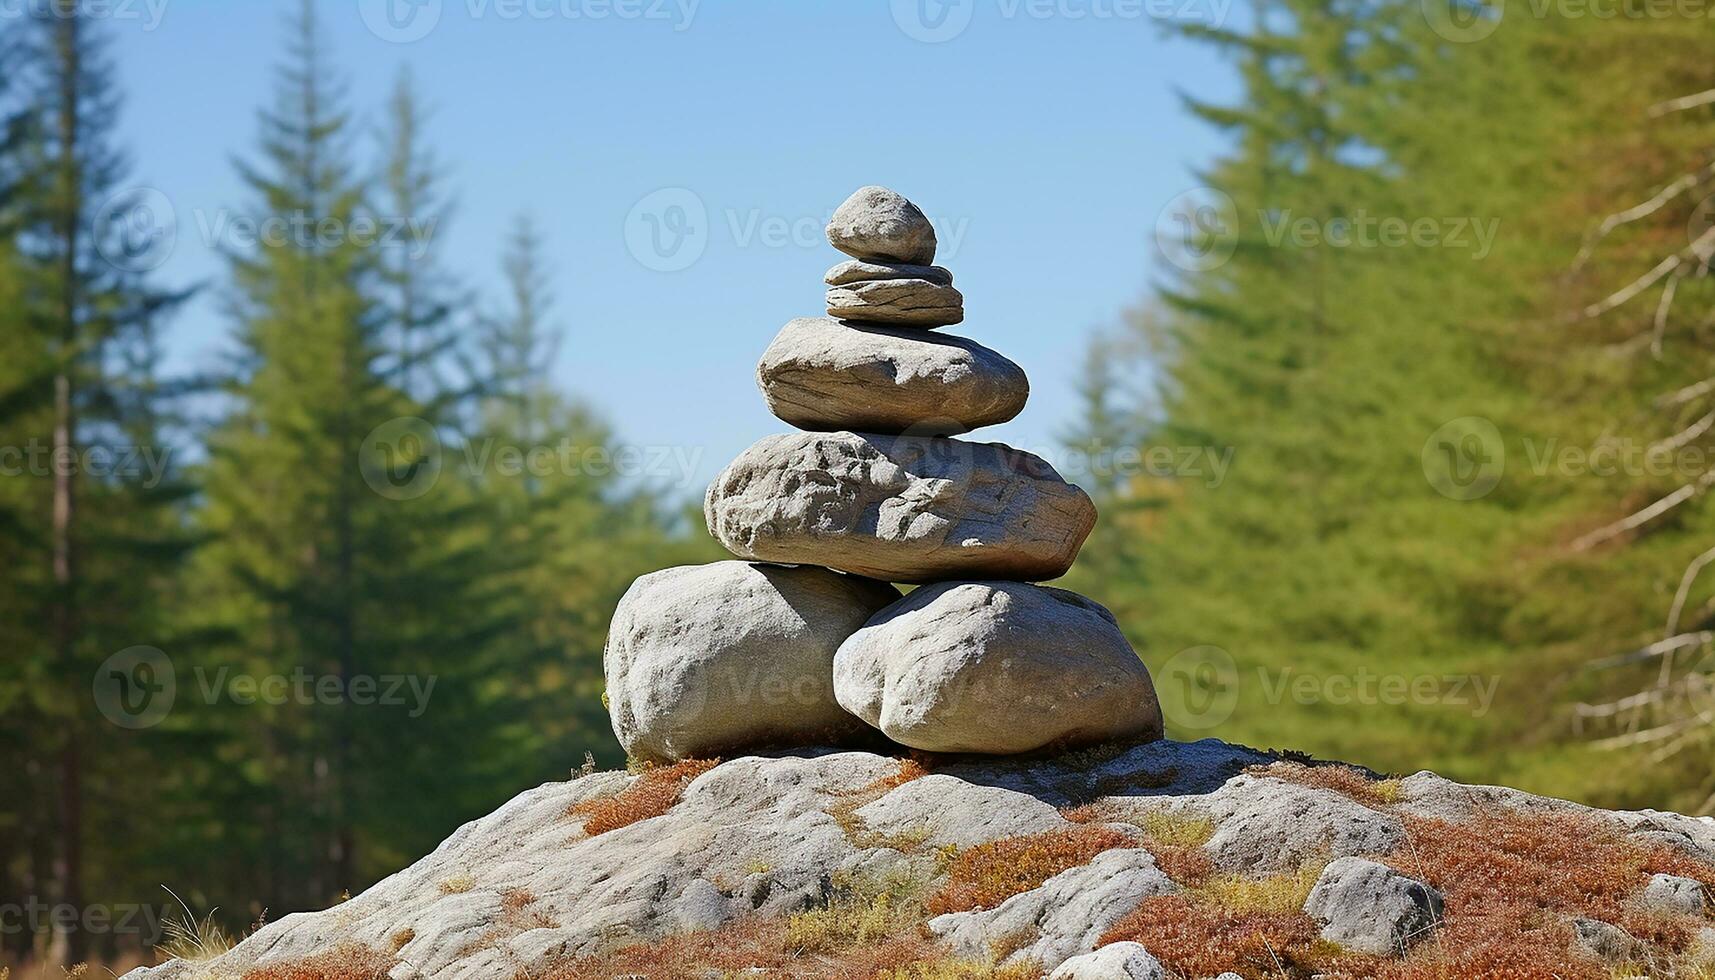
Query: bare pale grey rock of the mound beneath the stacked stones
127 740 1706 980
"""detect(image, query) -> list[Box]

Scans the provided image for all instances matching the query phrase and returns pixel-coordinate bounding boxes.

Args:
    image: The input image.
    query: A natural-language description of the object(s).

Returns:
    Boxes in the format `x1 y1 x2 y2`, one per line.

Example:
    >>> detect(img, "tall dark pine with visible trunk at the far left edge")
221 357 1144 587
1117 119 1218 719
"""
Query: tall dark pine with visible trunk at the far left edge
5 2 184 959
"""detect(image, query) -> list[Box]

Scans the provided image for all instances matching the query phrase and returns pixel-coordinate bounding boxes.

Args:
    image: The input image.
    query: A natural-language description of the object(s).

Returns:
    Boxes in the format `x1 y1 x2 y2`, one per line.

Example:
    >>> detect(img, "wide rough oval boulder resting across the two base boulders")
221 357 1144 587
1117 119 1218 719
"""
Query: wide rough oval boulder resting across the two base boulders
703 433 1096 582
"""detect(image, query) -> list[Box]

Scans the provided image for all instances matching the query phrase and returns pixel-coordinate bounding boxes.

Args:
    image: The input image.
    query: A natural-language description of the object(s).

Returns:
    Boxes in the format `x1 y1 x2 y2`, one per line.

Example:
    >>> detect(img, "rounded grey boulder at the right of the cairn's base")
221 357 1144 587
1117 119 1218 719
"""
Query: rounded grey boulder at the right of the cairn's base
833 582 1161 755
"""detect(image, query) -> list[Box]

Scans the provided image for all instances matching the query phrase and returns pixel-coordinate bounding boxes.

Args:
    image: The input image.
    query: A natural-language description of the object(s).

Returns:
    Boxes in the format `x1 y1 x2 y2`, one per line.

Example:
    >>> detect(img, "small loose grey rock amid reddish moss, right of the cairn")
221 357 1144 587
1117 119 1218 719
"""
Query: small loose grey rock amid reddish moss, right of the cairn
1303 858 1442 956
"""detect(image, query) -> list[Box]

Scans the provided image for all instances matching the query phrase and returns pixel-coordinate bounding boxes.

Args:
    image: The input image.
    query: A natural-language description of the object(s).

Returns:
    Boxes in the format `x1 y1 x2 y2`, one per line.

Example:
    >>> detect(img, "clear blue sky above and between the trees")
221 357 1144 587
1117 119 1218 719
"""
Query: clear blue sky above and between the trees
103 0 1235 493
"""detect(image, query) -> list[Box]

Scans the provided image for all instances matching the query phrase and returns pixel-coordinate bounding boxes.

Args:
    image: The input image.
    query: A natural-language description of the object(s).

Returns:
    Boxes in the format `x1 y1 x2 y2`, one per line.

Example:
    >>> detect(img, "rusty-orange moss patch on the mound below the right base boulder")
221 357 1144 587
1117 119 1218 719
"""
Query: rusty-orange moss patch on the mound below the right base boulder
930 827 1135 915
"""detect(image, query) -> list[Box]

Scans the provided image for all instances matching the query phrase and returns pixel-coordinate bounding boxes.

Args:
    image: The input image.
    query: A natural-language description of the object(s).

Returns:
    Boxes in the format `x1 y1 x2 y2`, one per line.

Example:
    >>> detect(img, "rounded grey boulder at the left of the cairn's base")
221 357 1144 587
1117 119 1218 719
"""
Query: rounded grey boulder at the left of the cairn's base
602 561 899 760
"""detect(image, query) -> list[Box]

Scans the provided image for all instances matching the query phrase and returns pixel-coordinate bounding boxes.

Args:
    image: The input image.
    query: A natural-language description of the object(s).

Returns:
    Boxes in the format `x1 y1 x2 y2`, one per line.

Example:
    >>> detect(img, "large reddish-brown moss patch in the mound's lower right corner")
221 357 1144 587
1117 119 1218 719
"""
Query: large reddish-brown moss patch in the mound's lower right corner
1384 814 1715 980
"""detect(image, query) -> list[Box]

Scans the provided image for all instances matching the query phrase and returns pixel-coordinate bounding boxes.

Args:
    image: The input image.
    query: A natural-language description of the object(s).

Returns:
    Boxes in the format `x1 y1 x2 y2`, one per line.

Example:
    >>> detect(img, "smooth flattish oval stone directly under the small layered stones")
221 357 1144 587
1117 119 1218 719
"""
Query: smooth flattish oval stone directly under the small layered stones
756 318 1031 434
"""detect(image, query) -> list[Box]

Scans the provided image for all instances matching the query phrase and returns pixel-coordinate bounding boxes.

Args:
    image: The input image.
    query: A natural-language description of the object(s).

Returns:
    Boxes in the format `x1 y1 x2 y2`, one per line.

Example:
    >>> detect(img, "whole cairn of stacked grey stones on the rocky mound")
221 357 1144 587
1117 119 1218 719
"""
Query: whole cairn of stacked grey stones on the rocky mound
604 187 1161 762
